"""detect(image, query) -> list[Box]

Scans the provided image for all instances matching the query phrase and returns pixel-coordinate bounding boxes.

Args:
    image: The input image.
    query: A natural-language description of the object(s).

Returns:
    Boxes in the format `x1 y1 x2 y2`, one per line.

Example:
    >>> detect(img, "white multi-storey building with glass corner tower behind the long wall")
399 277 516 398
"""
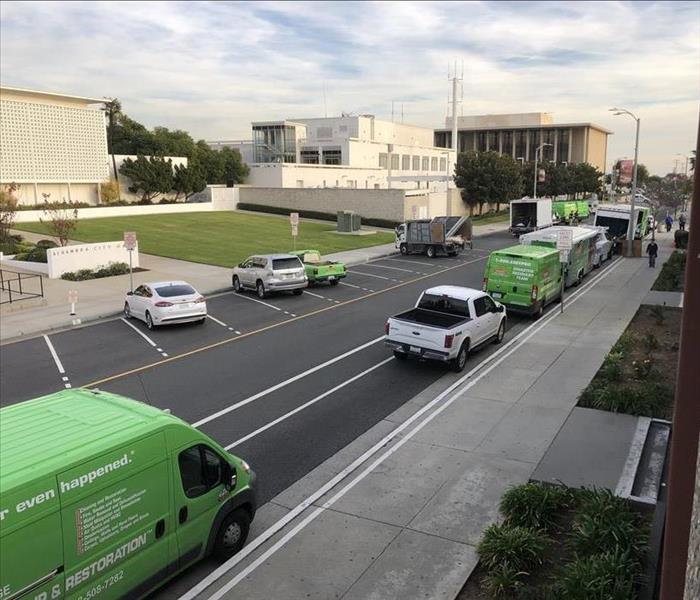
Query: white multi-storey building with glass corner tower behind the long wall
208 115 455 191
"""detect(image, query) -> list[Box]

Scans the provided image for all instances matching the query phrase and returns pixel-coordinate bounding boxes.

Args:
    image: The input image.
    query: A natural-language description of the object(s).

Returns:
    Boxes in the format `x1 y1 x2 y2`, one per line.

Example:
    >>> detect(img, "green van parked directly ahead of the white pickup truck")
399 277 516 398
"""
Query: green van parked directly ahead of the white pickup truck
483 245 561 318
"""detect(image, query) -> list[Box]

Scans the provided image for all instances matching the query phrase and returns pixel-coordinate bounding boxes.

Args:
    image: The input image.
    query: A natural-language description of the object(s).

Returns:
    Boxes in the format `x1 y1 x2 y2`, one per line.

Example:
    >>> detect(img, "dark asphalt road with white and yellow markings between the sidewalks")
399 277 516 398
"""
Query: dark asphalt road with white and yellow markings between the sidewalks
0 233 540 597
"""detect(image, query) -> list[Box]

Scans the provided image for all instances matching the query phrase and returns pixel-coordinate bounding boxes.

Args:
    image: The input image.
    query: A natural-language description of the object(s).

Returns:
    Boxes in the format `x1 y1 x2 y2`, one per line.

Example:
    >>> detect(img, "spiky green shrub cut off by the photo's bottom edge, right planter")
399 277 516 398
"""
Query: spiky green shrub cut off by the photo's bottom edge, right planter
555 551 638 600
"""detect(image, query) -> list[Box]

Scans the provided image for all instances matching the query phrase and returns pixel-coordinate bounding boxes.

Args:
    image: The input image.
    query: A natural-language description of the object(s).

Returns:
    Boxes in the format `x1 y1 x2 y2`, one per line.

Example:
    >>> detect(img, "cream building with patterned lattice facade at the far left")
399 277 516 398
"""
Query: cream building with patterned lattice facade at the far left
0 87 109 204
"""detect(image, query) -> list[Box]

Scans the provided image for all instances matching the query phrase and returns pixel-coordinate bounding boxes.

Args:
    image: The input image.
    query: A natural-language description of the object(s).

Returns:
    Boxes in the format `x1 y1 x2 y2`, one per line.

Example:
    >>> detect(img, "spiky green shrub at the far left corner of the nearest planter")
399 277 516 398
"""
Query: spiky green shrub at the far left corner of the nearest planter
500 482 571 530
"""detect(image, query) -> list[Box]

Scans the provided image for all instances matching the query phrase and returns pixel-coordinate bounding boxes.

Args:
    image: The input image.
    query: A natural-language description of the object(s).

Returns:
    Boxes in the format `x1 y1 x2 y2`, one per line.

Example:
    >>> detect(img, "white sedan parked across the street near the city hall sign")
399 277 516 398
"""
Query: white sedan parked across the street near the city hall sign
124 281 207 329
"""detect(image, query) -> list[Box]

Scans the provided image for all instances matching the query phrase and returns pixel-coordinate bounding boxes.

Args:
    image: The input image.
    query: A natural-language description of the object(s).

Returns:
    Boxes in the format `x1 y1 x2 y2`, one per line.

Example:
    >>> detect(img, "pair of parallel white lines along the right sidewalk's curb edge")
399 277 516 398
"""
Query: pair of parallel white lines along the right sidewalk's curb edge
179 259 623 600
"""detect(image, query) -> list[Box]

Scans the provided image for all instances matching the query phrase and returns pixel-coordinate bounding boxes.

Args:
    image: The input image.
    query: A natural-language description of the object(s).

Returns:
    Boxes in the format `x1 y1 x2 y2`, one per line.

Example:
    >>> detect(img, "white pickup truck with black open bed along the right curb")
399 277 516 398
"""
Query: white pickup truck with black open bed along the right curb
384 285 506 372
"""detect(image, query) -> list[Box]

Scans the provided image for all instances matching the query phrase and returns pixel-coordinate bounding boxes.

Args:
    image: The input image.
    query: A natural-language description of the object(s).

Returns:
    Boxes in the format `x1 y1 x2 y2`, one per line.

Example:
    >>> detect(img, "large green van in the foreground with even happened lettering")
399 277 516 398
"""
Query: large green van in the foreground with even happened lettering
0 389 256 600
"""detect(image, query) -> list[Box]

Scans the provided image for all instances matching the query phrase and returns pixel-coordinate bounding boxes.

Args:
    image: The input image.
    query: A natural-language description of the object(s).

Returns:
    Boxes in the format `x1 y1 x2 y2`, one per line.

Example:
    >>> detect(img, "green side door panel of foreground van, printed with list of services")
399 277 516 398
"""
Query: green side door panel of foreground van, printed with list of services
57 433 176 599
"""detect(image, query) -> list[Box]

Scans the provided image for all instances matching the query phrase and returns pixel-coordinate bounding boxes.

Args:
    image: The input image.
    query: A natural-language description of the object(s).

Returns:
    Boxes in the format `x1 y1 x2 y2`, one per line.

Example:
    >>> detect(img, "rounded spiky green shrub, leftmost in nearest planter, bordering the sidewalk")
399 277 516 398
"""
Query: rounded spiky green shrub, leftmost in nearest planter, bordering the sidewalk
477 523 549 572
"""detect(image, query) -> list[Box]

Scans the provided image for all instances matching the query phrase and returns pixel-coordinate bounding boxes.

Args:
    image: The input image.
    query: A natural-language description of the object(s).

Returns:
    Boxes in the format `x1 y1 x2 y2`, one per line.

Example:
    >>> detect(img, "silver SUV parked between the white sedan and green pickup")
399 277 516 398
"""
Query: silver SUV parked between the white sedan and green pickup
231 254 309 298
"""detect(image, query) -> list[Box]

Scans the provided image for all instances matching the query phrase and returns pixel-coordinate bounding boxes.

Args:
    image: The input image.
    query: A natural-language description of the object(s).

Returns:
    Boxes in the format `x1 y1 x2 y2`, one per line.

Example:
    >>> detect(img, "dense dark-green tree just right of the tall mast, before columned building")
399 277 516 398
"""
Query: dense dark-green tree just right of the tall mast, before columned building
454 151 522 213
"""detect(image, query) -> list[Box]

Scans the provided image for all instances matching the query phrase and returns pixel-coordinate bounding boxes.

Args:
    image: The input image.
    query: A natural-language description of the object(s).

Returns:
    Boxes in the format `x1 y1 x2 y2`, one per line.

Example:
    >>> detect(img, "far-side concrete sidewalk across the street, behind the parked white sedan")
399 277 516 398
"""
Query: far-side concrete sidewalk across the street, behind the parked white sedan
0 223 507 343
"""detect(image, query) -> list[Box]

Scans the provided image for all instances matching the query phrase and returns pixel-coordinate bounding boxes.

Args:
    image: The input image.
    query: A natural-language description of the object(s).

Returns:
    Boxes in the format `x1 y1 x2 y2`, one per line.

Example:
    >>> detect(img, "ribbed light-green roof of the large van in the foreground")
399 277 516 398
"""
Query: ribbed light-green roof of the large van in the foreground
0 389 182 491
